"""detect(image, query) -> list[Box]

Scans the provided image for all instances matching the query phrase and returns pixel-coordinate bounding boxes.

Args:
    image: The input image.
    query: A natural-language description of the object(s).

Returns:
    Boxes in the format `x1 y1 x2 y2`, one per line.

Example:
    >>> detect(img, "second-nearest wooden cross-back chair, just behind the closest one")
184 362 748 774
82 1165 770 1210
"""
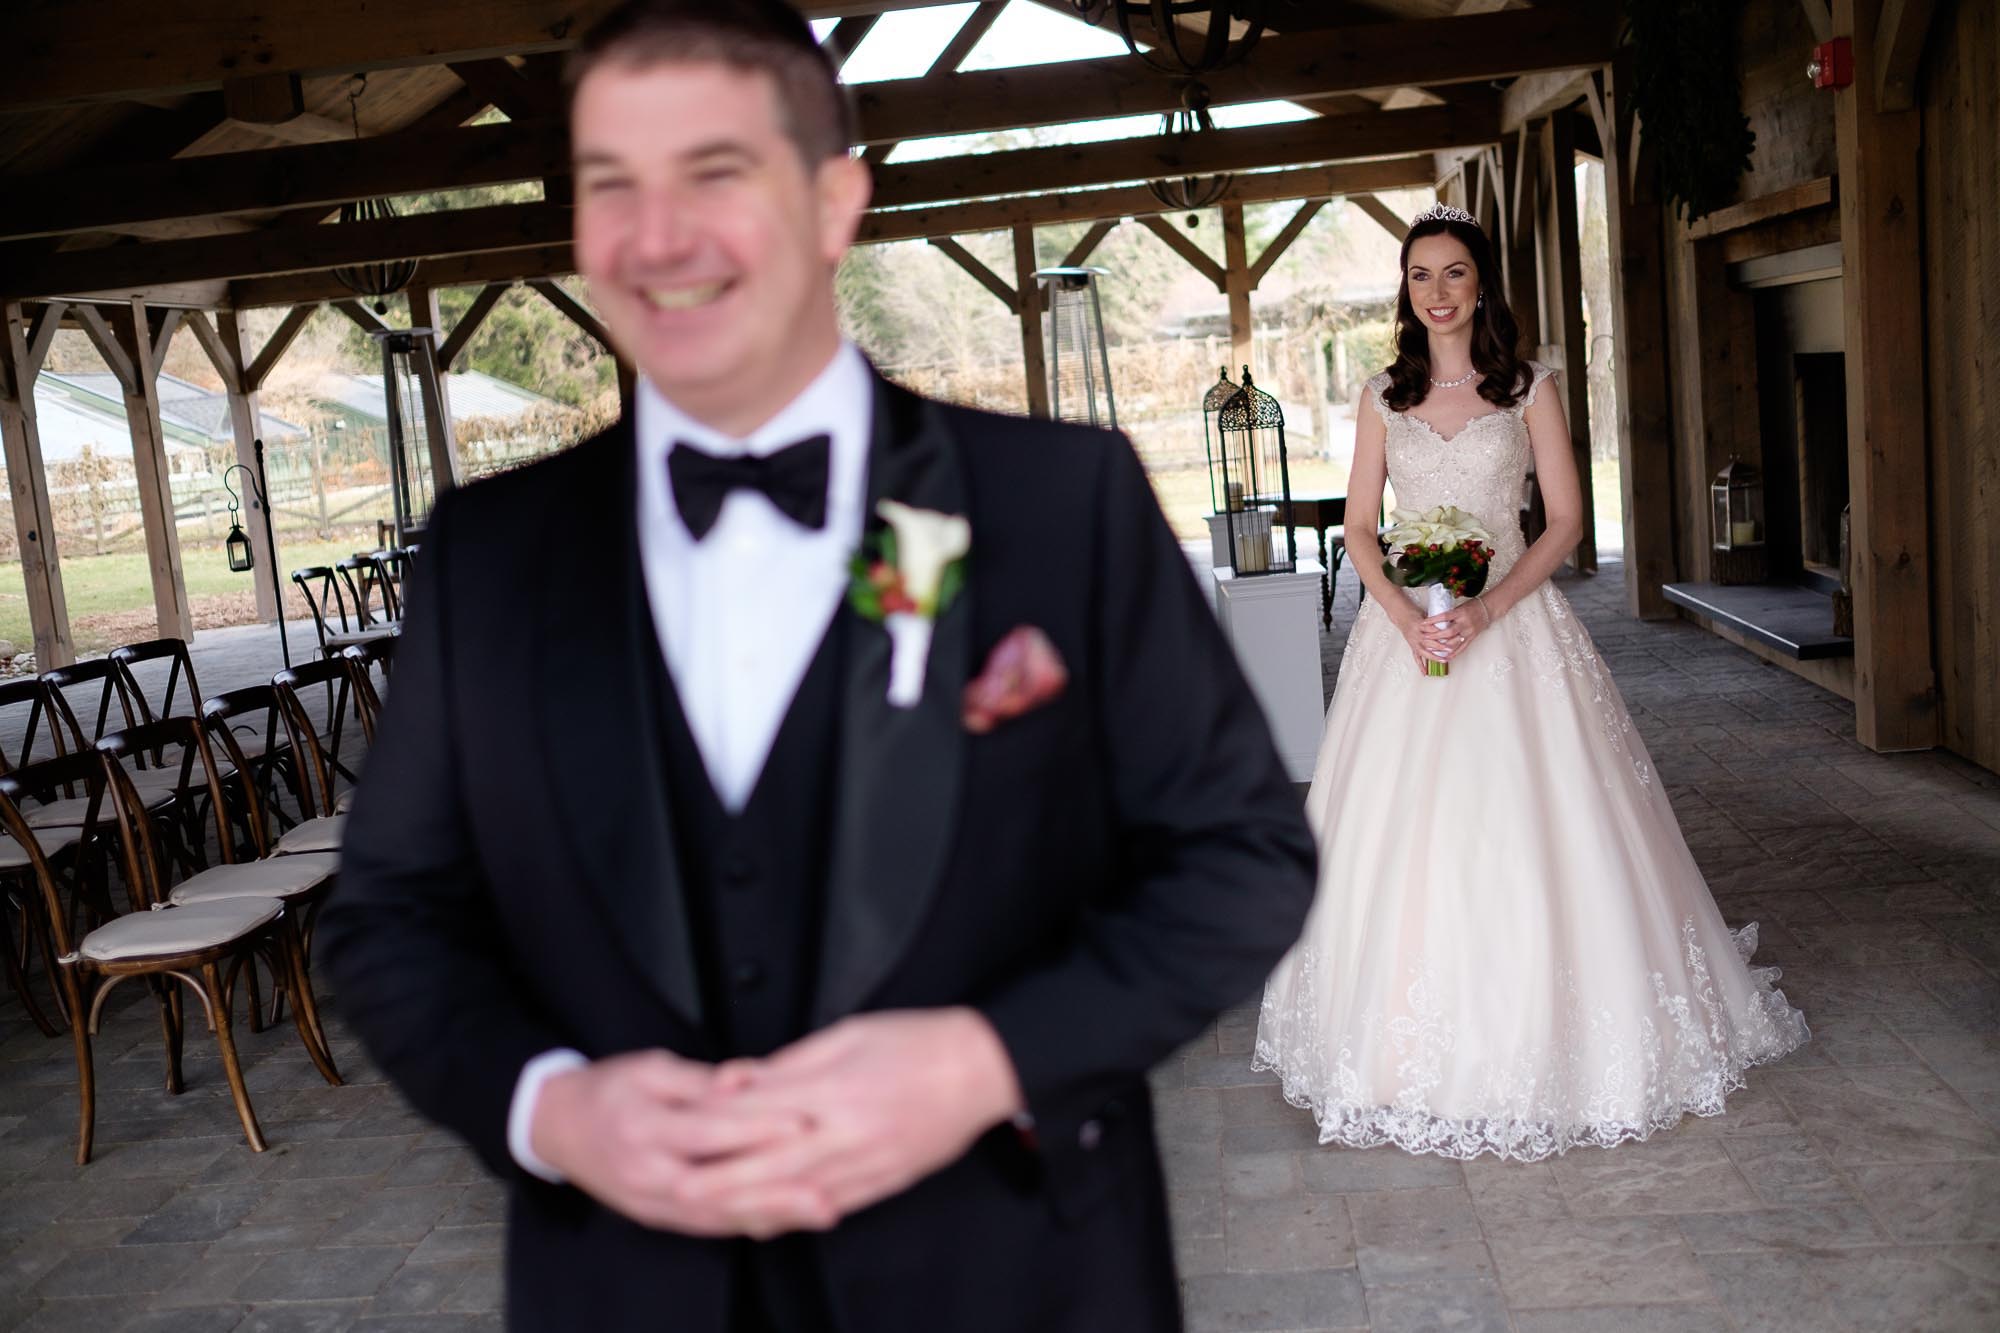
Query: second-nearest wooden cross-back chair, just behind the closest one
98 717 340 1073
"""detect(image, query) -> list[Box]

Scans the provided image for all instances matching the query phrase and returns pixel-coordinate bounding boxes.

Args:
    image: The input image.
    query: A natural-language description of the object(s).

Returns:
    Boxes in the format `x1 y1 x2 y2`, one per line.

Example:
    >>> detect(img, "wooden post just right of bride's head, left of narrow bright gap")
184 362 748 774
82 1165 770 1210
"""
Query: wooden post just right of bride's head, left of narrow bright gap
1536 114 1598 574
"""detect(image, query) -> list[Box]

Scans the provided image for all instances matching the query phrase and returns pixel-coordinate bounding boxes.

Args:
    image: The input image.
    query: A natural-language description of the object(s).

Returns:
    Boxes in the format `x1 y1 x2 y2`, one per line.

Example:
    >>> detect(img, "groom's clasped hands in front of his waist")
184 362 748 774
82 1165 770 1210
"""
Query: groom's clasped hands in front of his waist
530 1009 1022 1239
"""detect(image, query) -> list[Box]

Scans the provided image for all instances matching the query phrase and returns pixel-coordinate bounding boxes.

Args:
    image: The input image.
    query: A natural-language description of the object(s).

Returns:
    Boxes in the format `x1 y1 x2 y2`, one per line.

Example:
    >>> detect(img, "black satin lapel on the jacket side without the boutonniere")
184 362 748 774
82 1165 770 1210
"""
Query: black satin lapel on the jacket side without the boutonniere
522 426 702 1025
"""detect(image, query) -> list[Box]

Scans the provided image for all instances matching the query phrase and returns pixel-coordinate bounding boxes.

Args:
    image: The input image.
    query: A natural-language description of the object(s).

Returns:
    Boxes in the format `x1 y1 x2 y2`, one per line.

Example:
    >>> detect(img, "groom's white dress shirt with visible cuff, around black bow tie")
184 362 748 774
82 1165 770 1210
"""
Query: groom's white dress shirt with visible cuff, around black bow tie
508 342 874 1181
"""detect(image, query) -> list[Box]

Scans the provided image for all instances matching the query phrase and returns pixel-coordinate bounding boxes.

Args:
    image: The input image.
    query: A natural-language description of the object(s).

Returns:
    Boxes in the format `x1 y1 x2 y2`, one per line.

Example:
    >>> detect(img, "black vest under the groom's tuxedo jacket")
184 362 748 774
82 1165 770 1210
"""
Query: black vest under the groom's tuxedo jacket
642 610 848 1333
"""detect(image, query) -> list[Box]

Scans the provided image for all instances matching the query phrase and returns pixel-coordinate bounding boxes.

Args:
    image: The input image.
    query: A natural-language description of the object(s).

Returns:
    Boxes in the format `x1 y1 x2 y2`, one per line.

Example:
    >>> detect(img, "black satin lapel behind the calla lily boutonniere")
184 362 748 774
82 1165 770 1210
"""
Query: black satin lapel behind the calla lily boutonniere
812 378 980 1027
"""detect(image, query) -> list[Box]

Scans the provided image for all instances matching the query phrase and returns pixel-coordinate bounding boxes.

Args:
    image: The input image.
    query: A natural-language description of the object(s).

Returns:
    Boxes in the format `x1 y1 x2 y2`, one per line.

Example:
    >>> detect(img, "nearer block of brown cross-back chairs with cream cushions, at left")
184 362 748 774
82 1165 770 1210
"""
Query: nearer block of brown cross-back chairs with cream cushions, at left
0 640 394 1165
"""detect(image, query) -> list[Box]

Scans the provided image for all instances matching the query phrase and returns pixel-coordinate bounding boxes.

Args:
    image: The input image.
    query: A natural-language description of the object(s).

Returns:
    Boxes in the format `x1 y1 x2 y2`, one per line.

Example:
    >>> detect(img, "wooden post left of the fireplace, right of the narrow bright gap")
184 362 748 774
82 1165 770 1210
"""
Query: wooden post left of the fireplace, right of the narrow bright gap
1604 72 1676 620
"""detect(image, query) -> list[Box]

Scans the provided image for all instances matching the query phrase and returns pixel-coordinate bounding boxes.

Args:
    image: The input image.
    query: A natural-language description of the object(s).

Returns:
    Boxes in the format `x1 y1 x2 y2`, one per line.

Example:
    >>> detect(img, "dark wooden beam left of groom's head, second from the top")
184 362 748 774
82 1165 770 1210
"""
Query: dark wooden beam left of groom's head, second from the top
0 118 570 236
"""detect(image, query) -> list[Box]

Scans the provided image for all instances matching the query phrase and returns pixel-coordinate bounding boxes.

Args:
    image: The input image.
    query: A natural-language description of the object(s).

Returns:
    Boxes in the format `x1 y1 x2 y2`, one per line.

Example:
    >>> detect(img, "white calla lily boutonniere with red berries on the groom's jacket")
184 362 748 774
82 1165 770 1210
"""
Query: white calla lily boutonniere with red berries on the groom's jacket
848 500 972 709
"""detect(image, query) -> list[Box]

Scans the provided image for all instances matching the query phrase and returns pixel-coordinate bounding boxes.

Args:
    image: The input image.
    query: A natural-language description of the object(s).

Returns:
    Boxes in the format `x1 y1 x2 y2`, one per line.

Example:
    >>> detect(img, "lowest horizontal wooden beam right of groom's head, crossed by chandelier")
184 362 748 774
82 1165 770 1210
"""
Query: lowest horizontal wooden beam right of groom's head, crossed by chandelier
860 154 1432 244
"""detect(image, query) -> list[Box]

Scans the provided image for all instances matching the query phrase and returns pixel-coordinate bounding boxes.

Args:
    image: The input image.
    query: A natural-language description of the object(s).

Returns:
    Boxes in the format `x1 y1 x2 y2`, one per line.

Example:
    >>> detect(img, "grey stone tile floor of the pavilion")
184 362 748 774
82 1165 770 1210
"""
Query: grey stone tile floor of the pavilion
0 566 2000 1333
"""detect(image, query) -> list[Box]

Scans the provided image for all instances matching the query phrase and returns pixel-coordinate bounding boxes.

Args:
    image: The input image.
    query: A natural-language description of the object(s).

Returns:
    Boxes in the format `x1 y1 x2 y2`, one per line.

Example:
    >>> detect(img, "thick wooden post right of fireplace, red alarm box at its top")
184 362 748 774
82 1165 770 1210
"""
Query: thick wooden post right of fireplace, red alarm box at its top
1834 0 1938 751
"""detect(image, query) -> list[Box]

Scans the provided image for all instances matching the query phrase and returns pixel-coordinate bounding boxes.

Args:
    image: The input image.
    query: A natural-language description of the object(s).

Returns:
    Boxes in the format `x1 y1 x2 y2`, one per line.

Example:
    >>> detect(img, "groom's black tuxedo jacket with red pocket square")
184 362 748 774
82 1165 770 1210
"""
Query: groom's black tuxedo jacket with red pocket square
316 370 1314 1333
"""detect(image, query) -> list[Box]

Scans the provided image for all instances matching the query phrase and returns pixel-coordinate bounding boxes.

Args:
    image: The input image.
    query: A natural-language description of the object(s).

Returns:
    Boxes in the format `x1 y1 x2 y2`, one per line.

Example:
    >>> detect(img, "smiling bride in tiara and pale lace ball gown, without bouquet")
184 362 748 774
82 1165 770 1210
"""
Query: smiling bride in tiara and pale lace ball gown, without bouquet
1256 204 1808 1161
